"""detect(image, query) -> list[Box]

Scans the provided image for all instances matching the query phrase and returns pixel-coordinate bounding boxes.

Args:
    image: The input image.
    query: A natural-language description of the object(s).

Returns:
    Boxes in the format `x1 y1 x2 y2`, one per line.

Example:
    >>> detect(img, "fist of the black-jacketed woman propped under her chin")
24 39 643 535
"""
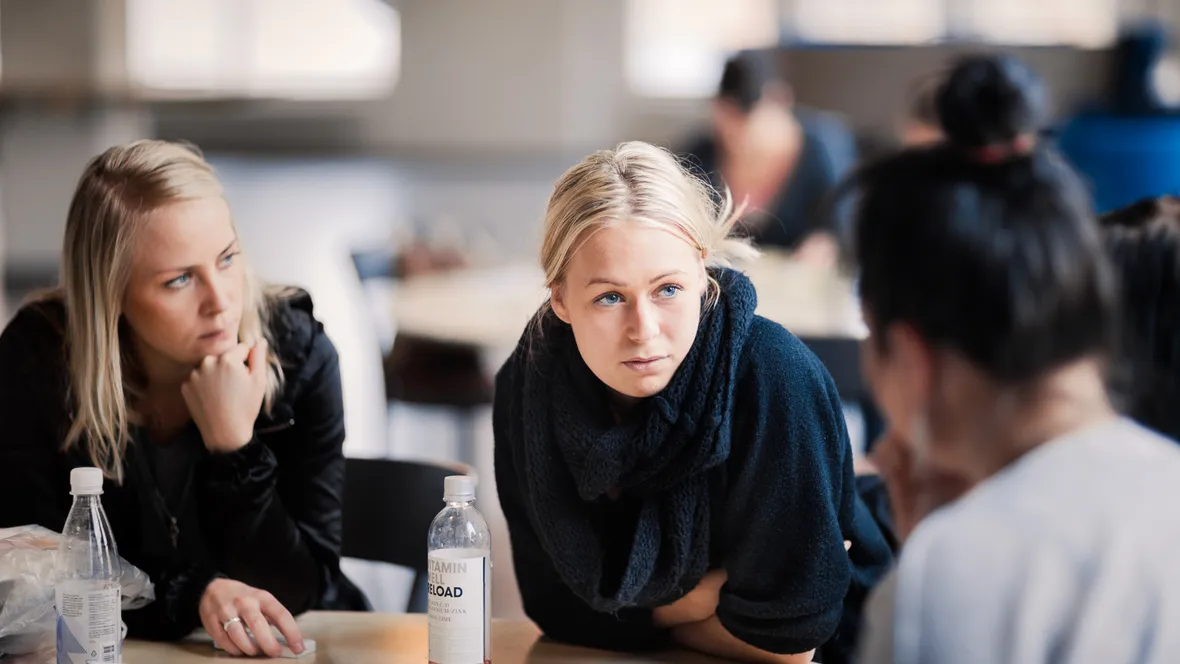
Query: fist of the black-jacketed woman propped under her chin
181 338 268 453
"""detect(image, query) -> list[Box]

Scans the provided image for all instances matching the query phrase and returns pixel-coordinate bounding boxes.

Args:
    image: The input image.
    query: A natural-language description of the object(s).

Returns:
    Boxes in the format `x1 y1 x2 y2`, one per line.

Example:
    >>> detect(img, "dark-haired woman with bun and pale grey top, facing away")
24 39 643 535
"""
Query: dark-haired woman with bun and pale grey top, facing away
853 55 1180 664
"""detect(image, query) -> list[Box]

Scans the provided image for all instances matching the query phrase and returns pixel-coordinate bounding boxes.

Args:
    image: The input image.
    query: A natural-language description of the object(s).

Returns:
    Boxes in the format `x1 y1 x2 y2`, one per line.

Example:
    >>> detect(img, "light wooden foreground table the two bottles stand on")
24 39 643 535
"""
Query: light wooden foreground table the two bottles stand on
123 612 741 664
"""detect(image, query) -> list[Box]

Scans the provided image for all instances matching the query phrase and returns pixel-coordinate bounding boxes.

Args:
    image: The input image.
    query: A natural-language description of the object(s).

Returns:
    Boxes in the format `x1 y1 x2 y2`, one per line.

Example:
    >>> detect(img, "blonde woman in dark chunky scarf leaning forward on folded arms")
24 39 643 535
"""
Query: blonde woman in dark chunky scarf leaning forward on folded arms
494 143 891 663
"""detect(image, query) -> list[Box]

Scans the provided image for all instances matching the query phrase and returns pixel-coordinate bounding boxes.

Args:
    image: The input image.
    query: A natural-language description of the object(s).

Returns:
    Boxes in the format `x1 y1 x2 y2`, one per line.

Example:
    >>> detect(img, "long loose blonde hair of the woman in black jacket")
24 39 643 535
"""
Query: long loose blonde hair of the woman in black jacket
42 139 283 482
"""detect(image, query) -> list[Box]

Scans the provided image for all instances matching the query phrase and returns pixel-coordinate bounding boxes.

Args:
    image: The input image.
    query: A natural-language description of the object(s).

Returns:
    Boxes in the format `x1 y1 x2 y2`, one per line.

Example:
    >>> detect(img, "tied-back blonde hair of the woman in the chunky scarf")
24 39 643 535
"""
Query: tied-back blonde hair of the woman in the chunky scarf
540 140 758 313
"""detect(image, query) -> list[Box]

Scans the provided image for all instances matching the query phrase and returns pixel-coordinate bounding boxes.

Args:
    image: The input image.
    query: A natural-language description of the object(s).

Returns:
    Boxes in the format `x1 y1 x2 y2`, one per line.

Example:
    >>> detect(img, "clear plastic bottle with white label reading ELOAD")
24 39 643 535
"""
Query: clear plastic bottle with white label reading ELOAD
427 475 492 664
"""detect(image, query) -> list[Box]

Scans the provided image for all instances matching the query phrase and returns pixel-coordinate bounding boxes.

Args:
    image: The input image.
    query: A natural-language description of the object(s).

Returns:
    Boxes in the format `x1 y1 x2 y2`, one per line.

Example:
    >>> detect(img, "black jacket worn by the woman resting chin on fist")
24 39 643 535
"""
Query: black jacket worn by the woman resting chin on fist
0 292 367 639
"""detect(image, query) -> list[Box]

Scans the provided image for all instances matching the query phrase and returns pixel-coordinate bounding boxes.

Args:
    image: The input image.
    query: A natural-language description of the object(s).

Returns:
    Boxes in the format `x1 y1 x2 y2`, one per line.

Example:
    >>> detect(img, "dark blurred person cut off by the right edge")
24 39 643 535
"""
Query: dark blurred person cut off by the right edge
1100 196 1180 440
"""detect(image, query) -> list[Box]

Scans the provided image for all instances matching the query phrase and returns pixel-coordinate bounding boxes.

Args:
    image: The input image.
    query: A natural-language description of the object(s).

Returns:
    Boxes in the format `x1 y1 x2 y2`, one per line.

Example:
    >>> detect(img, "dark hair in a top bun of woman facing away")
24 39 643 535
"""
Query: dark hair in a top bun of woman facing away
841 55 1115 383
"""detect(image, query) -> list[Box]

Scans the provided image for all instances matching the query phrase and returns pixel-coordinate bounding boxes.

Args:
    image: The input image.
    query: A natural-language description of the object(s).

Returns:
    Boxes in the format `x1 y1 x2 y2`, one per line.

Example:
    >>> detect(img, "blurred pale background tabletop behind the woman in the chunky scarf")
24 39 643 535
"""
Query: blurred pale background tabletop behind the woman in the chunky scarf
392 252 865 350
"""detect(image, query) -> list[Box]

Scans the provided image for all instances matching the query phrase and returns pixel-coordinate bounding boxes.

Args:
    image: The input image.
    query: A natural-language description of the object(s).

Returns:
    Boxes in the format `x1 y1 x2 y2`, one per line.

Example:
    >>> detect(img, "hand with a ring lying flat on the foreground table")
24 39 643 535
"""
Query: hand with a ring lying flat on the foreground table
199 579 303 657
